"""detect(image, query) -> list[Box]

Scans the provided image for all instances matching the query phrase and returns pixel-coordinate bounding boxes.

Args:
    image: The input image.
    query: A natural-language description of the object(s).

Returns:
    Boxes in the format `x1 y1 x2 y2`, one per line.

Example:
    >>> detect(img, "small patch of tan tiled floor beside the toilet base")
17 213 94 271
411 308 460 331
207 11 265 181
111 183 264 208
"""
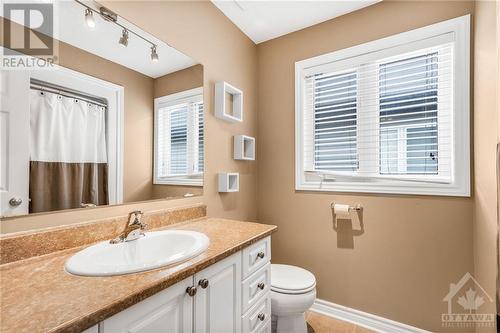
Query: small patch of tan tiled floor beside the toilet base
306 311 374 333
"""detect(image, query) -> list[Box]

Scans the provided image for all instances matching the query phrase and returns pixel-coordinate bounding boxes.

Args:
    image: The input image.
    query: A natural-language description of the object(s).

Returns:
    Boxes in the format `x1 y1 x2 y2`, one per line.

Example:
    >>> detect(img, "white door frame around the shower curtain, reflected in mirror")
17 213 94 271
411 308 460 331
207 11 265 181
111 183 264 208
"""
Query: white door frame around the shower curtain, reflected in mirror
30 65 124 205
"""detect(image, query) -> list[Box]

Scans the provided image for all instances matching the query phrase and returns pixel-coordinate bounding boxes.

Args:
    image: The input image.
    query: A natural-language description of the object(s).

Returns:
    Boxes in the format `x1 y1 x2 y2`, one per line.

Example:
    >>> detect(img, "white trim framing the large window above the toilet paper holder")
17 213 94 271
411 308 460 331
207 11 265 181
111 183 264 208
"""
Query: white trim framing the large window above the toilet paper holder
295 15 470 197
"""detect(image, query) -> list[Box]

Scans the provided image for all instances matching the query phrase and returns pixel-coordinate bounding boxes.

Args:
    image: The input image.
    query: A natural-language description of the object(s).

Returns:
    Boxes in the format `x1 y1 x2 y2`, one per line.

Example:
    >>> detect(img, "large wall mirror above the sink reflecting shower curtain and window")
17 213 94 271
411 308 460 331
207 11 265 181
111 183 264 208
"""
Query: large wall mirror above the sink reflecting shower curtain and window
0 1 204 218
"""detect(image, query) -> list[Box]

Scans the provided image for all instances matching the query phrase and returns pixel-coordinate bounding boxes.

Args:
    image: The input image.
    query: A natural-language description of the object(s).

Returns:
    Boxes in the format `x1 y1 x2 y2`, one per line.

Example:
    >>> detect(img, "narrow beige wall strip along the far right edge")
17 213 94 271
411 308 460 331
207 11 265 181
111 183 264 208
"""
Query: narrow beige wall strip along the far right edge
473 1 500 332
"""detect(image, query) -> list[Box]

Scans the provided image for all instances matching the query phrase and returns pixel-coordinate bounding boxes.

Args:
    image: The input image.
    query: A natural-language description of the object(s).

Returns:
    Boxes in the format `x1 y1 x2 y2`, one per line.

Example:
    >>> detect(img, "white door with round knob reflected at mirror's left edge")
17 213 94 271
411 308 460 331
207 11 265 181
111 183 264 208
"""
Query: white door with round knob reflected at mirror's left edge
0 70 30 215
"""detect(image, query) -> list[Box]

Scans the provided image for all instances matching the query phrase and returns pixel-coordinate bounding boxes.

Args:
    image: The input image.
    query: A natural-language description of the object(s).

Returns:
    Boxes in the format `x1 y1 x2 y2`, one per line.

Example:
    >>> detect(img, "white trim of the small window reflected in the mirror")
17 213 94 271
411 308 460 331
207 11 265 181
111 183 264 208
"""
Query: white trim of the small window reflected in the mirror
153 87 204 187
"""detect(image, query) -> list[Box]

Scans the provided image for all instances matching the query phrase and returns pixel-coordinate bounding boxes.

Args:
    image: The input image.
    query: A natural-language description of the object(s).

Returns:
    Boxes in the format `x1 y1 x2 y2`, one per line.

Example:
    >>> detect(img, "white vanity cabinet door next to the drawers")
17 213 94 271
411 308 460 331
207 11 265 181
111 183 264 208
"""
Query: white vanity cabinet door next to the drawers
194 252 241 333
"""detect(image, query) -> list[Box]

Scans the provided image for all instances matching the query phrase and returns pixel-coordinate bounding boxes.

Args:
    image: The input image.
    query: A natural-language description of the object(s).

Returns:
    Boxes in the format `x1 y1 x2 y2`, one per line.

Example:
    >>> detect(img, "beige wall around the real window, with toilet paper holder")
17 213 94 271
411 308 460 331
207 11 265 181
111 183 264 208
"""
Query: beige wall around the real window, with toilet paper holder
257 1 474 332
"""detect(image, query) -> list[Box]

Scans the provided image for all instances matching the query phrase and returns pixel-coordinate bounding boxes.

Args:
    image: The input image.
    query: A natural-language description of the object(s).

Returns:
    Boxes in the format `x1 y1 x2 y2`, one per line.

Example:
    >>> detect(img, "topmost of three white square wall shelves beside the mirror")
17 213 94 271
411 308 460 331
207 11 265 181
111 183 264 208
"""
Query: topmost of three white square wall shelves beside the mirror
215 82 243 123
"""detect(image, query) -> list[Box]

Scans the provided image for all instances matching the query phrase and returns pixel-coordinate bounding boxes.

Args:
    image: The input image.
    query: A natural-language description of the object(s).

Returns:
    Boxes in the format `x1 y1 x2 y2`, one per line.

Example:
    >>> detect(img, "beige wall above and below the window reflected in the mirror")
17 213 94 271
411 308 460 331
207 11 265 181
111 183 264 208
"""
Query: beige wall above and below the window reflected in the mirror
151 65 203 199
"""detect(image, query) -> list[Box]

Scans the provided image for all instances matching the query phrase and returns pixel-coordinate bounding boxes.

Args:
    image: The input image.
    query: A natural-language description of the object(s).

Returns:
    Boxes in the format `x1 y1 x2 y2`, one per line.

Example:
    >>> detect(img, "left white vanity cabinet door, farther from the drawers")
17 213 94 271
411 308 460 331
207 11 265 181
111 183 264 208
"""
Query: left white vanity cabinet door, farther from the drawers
100 277 194 333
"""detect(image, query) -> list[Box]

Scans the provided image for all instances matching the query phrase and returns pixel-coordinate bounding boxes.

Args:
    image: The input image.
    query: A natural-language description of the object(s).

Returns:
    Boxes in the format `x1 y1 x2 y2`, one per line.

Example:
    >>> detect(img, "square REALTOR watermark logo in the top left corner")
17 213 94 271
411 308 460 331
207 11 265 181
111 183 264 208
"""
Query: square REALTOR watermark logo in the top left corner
0 1 59 70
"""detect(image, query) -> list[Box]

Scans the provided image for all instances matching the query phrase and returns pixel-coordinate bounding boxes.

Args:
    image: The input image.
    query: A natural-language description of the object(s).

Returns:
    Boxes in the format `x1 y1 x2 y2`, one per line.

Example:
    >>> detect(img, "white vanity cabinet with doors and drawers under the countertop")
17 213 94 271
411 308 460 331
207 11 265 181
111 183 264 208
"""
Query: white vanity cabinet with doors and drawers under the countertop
85 237 271 333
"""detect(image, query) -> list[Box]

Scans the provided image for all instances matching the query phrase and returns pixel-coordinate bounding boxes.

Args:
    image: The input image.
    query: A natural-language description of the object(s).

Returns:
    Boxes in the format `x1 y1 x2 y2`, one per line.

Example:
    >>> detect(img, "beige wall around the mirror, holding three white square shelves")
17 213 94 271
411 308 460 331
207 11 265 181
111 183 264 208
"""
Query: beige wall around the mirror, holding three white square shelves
0 1 257 232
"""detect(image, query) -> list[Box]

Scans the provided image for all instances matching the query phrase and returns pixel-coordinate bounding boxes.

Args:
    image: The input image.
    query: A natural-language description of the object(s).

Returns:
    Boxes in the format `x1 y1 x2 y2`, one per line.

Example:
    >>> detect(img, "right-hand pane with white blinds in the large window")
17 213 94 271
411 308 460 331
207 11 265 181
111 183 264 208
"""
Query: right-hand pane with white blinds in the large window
378 51 440 176
